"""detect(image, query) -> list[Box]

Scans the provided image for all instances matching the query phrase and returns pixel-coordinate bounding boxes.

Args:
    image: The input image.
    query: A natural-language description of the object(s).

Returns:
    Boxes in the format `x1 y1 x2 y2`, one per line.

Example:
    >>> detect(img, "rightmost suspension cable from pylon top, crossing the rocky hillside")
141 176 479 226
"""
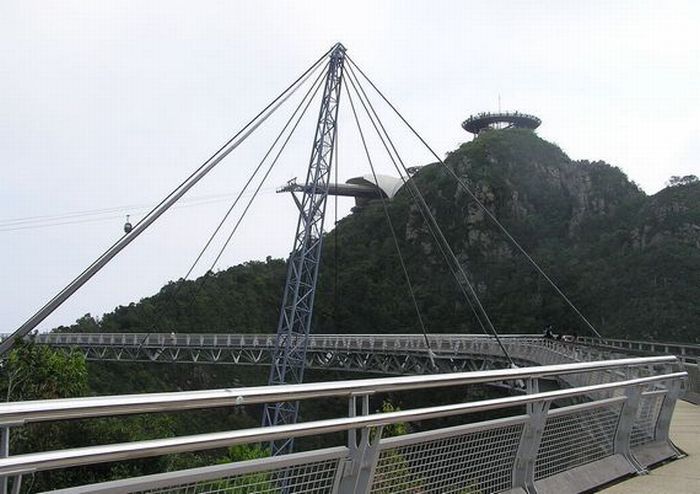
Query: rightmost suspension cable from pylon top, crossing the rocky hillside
347 56 601 338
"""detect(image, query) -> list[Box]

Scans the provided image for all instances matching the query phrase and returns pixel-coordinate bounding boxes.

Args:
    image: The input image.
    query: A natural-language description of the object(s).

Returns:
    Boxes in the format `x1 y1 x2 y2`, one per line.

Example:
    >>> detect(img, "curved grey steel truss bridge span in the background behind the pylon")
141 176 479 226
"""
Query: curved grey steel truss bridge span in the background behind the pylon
28 333 618 375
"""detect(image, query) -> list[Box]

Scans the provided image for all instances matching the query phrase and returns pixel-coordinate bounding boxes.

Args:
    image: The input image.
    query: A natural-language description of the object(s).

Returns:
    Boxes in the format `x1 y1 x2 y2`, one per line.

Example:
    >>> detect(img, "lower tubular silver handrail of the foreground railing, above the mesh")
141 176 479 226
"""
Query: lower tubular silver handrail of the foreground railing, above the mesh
0 372 688 475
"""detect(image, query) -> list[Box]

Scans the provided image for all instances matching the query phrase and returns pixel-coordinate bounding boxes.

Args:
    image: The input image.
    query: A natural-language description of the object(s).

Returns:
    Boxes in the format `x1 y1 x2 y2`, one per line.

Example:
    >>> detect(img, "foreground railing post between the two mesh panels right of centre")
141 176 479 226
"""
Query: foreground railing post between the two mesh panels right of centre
513 379 550 494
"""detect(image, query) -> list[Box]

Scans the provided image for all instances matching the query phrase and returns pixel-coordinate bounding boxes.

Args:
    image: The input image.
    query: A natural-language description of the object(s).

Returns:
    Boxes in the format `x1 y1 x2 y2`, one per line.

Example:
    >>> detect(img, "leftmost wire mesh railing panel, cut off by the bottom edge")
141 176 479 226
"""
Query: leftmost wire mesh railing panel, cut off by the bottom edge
129 459 339 494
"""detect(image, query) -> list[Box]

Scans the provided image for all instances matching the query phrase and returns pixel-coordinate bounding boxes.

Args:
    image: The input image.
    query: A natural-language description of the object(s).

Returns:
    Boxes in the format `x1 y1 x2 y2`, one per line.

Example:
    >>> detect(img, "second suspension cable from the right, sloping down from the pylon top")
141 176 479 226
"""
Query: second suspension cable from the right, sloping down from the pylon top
348 63 515 366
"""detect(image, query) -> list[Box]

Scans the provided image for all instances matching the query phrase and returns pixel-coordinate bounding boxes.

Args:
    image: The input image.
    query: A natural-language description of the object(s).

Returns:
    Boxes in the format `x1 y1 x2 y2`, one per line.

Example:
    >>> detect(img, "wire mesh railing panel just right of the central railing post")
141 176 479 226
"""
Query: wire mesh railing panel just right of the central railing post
370 423 523 494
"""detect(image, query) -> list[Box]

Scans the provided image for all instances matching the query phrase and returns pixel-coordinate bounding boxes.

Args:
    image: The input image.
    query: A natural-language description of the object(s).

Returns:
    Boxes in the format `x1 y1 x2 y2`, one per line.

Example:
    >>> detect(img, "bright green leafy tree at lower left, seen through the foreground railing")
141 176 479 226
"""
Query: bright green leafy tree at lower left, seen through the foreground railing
0 340 183 492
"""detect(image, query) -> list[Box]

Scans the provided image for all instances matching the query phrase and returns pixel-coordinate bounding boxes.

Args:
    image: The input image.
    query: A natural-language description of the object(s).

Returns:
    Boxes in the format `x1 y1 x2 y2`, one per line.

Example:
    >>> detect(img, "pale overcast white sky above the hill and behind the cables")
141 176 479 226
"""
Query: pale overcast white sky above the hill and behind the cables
0 0 700 333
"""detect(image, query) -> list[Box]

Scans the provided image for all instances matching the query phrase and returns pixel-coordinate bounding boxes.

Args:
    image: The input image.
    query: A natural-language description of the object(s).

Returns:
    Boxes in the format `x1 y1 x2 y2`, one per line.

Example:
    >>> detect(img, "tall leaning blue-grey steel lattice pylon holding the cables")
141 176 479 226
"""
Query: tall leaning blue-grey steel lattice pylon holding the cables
263 43 345 455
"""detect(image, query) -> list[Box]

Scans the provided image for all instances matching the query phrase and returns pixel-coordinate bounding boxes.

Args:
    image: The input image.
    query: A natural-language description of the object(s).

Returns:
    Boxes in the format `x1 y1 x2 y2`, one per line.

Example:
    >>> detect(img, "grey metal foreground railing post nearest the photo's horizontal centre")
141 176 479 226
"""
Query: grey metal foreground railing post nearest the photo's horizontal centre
334 394 383 494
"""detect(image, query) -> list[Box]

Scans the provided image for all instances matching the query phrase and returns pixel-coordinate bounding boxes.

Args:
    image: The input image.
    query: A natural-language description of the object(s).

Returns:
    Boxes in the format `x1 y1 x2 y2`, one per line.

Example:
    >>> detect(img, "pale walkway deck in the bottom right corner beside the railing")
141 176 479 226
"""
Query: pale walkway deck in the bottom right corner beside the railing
602 400 700 494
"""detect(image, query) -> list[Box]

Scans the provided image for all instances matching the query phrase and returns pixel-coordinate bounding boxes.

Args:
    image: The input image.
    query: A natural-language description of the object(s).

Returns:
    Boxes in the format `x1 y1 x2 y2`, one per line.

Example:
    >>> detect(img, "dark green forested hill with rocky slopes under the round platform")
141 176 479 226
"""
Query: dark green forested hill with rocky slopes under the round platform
59 130 700 341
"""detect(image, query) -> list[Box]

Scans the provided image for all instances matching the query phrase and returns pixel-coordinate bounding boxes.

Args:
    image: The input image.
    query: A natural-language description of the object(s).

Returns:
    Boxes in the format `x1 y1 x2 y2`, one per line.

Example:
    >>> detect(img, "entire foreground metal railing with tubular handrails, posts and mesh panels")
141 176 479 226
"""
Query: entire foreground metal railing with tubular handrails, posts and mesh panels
0 357 687 494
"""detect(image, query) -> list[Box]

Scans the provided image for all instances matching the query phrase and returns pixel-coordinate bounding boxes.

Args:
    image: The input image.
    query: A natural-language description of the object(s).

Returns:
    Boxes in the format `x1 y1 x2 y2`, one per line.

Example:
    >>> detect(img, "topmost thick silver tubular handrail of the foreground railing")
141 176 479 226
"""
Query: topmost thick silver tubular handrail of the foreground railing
0 356 678 425
